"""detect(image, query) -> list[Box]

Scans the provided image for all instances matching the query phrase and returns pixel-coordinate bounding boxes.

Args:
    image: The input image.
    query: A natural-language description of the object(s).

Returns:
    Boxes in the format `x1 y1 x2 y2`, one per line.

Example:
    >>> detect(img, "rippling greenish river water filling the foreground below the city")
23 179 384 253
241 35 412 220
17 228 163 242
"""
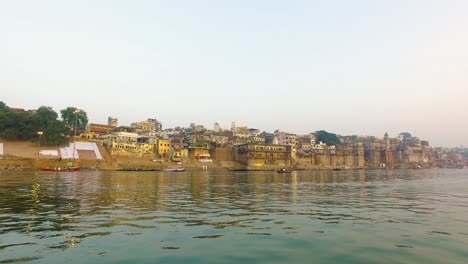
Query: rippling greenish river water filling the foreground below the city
0 169 468 263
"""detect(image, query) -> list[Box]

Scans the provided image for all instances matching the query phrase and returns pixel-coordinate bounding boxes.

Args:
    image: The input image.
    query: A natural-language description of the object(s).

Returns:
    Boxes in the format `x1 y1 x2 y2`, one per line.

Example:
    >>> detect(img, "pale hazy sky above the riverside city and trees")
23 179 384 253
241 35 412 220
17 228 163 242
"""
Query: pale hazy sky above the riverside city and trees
0 0 468 146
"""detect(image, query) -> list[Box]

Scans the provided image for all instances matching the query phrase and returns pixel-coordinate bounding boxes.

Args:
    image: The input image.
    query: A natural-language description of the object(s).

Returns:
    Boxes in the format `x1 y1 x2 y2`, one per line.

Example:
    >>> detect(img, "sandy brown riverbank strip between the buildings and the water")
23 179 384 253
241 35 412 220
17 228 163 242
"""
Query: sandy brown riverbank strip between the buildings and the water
0 141 432 171
